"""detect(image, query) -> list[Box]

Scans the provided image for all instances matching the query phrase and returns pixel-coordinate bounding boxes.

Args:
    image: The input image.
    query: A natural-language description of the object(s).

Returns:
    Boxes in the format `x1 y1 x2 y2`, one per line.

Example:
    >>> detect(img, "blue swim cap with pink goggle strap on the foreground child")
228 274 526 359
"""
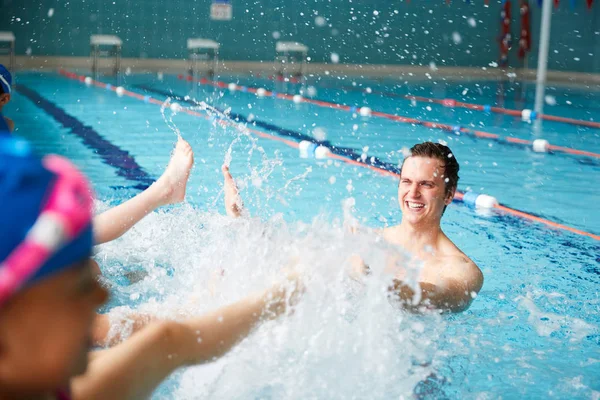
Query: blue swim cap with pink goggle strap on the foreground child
0 136 93 307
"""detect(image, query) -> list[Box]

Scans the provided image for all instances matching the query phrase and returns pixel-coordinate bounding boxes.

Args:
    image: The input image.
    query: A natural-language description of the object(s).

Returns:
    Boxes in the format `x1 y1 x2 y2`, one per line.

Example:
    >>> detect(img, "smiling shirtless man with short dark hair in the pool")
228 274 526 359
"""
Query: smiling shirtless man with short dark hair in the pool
381 142 483 312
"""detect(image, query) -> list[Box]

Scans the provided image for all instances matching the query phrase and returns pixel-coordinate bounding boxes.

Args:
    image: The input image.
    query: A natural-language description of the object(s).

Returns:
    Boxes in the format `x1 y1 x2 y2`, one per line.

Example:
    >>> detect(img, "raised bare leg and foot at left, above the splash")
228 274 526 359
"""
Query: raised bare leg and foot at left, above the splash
94 139 194 244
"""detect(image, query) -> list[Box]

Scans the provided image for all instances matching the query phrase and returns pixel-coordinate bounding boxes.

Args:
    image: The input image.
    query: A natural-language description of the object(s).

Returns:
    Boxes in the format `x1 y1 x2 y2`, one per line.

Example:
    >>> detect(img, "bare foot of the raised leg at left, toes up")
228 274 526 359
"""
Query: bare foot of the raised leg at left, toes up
156 138 194 205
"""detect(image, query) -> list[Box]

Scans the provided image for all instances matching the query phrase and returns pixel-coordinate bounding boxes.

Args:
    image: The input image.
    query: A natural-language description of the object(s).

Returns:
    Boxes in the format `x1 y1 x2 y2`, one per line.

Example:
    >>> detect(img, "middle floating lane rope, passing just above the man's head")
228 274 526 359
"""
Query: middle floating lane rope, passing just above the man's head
178 74 600 159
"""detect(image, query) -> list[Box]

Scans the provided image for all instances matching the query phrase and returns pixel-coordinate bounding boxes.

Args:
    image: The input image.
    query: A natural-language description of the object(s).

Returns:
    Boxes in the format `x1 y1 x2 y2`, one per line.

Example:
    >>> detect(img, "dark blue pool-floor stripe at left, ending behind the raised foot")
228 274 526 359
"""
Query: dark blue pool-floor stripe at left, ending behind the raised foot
15 84 154 190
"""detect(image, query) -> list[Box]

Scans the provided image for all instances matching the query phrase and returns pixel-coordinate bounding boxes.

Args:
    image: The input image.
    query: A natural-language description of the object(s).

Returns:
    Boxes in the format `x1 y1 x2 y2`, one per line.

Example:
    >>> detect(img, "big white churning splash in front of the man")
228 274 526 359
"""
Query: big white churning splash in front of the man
96 200 445 399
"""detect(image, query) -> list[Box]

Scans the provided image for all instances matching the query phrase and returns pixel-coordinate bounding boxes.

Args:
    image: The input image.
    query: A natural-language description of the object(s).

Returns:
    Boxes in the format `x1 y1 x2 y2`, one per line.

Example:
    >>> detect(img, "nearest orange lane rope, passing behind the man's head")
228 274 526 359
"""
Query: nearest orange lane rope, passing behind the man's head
59 69 600 241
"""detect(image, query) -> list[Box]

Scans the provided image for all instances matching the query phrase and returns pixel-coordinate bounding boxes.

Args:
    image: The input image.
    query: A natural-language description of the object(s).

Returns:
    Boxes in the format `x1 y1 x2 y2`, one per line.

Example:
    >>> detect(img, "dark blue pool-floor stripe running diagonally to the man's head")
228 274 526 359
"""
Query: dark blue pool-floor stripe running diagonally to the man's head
134 85 400 173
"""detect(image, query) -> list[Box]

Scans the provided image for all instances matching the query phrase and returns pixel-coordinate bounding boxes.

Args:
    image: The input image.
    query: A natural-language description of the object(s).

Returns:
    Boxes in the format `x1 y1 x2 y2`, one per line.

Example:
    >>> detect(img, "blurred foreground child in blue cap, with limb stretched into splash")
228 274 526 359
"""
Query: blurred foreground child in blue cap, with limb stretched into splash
0 135 301 400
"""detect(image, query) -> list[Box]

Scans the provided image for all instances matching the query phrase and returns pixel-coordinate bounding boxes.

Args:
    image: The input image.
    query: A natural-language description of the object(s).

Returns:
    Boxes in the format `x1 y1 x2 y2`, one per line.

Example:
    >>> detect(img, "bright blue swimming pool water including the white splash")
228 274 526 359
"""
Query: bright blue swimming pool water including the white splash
5 73 600 399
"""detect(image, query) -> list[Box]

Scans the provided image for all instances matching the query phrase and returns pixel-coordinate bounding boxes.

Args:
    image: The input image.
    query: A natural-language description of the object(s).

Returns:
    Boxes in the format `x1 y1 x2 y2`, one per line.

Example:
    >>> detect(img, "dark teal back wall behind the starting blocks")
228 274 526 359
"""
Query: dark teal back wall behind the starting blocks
0 0 600 72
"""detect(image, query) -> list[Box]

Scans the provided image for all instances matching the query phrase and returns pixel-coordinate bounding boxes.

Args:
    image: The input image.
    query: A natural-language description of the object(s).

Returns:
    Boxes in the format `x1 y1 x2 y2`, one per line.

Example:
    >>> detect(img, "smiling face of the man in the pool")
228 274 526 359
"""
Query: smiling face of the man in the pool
398 156 454 225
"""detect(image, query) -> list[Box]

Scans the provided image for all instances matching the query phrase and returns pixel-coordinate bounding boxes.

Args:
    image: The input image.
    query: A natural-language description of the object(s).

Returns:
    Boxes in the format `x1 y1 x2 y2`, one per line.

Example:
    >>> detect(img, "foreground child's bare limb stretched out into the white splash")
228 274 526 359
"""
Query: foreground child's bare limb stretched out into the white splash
72 281 301 400
